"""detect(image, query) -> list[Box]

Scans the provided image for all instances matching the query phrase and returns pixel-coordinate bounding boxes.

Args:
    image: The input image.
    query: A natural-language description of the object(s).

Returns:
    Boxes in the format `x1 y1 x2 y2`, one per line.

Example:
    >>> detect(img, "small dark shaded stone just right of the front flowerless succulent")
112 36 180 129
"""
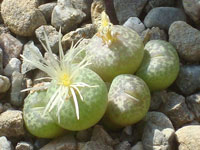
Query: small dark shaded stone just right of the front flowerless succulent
150 91 167 110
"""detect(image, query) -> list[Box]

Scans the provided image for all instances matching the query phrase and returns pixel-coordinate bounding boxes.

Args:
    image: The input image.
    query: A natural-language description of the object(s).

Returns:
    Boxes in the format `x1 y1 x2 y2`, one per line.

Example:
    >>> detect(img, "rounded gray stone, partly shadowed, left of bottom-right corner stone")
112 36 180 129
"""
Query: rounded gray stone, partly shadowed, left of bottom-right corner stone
142 112 174 150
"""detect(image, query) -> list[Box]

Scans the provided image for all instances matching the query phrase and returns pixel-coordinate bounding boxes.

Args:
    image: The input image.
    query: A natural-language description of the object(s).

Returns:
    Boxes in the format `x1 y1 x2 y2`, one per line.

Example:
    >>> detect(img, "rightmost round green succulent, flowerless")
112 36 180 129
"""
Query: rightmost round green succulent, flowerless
136 40 179 91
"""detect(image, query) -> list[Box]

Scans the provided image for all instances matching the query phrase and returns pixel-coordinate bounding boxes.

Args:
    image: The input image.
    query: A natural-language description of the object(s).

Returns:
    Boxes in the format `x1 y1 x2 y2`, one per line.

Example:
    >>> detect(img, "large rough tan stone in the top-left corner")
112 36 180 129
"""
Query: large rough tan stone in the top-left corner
1 0 46 36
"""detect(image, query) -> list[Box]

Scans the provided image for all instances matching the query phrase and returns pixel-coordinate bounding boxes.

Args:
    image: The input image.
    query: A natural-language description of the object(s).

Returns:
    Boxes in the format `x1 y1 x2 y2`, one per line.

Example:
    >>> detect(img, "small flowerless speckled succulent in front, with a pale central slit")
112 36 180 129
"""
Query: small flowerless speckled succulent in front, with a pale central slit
103 74 151 129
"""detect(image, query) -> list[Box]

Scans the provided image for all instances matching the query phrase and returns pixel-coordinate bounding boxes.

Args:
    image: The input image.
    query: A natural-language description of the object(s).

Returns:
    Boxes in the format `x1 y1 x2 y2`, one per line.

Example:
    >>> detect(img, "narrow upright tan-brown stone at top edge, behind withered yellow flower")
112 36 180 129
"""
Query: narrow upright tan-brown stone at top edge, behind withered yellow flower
91 0 106 27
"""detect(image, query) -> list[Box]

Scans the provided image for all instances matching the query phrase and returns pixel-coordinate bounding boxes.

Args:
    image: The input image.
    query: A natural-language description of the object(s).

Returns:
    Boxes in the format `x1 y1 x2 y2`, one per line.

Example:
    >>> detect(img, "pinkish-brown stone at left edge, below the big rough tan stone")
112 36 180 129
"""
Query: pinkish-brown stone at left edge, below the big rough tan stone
0 33 23 66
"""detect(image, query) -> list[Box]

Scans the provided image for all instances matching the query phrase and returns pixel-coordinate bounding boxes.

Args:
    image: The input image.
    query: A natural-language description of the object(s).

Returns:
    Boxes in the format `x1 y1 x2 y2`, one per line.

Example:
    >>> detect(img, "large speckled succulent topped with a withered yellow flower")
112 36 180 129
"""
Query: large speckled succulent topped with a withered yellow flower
73 12 144 82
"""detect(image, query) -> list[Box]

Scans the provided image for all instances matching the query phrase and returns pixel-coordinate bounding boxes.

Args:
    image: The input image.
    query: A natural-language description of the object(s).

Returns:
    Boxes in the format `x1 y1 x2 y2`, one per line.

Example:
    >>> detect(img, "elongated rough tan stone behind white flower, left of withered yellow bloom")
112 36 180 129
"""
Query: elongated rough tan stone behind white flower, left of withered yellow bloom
62 24 96 49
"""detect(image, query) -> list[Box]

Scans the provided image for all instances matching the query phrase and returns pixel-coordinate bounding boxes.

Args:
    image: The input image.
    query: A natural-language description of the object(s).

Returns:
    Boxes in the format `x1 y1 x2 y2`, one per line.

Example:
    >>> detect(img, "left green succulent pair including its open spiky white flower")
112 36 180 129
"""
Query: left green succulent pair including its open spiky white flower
22 28 108 137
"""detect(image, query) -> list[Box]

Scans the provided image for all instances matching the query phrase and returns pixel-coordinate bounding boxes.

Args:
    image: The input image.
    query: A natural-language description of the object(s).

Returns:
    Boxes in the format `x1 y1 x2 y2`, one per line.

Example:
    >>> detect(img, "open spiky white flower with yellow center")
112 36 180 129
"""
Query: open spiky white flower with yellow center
21 30 96 122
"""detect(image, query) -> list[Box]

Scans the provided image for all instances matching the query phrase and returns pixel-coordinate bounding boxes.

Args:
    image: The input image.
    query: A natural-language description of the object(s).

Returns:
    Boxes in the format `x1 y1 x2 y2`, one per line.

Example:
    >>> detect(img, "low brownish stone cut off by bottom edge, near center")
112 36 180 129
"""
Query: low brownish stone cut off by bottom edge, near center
80 141 113 150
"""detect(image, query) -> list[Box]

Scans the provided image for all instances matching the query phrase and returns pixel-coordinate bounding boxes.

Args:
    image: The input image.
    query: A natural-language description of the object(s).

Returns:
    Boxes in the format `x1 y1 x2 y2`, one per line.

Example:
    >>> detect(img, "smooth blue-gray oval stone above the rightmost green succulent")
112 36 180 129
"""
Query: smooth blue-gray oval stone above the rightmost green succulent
144 7 186 30
